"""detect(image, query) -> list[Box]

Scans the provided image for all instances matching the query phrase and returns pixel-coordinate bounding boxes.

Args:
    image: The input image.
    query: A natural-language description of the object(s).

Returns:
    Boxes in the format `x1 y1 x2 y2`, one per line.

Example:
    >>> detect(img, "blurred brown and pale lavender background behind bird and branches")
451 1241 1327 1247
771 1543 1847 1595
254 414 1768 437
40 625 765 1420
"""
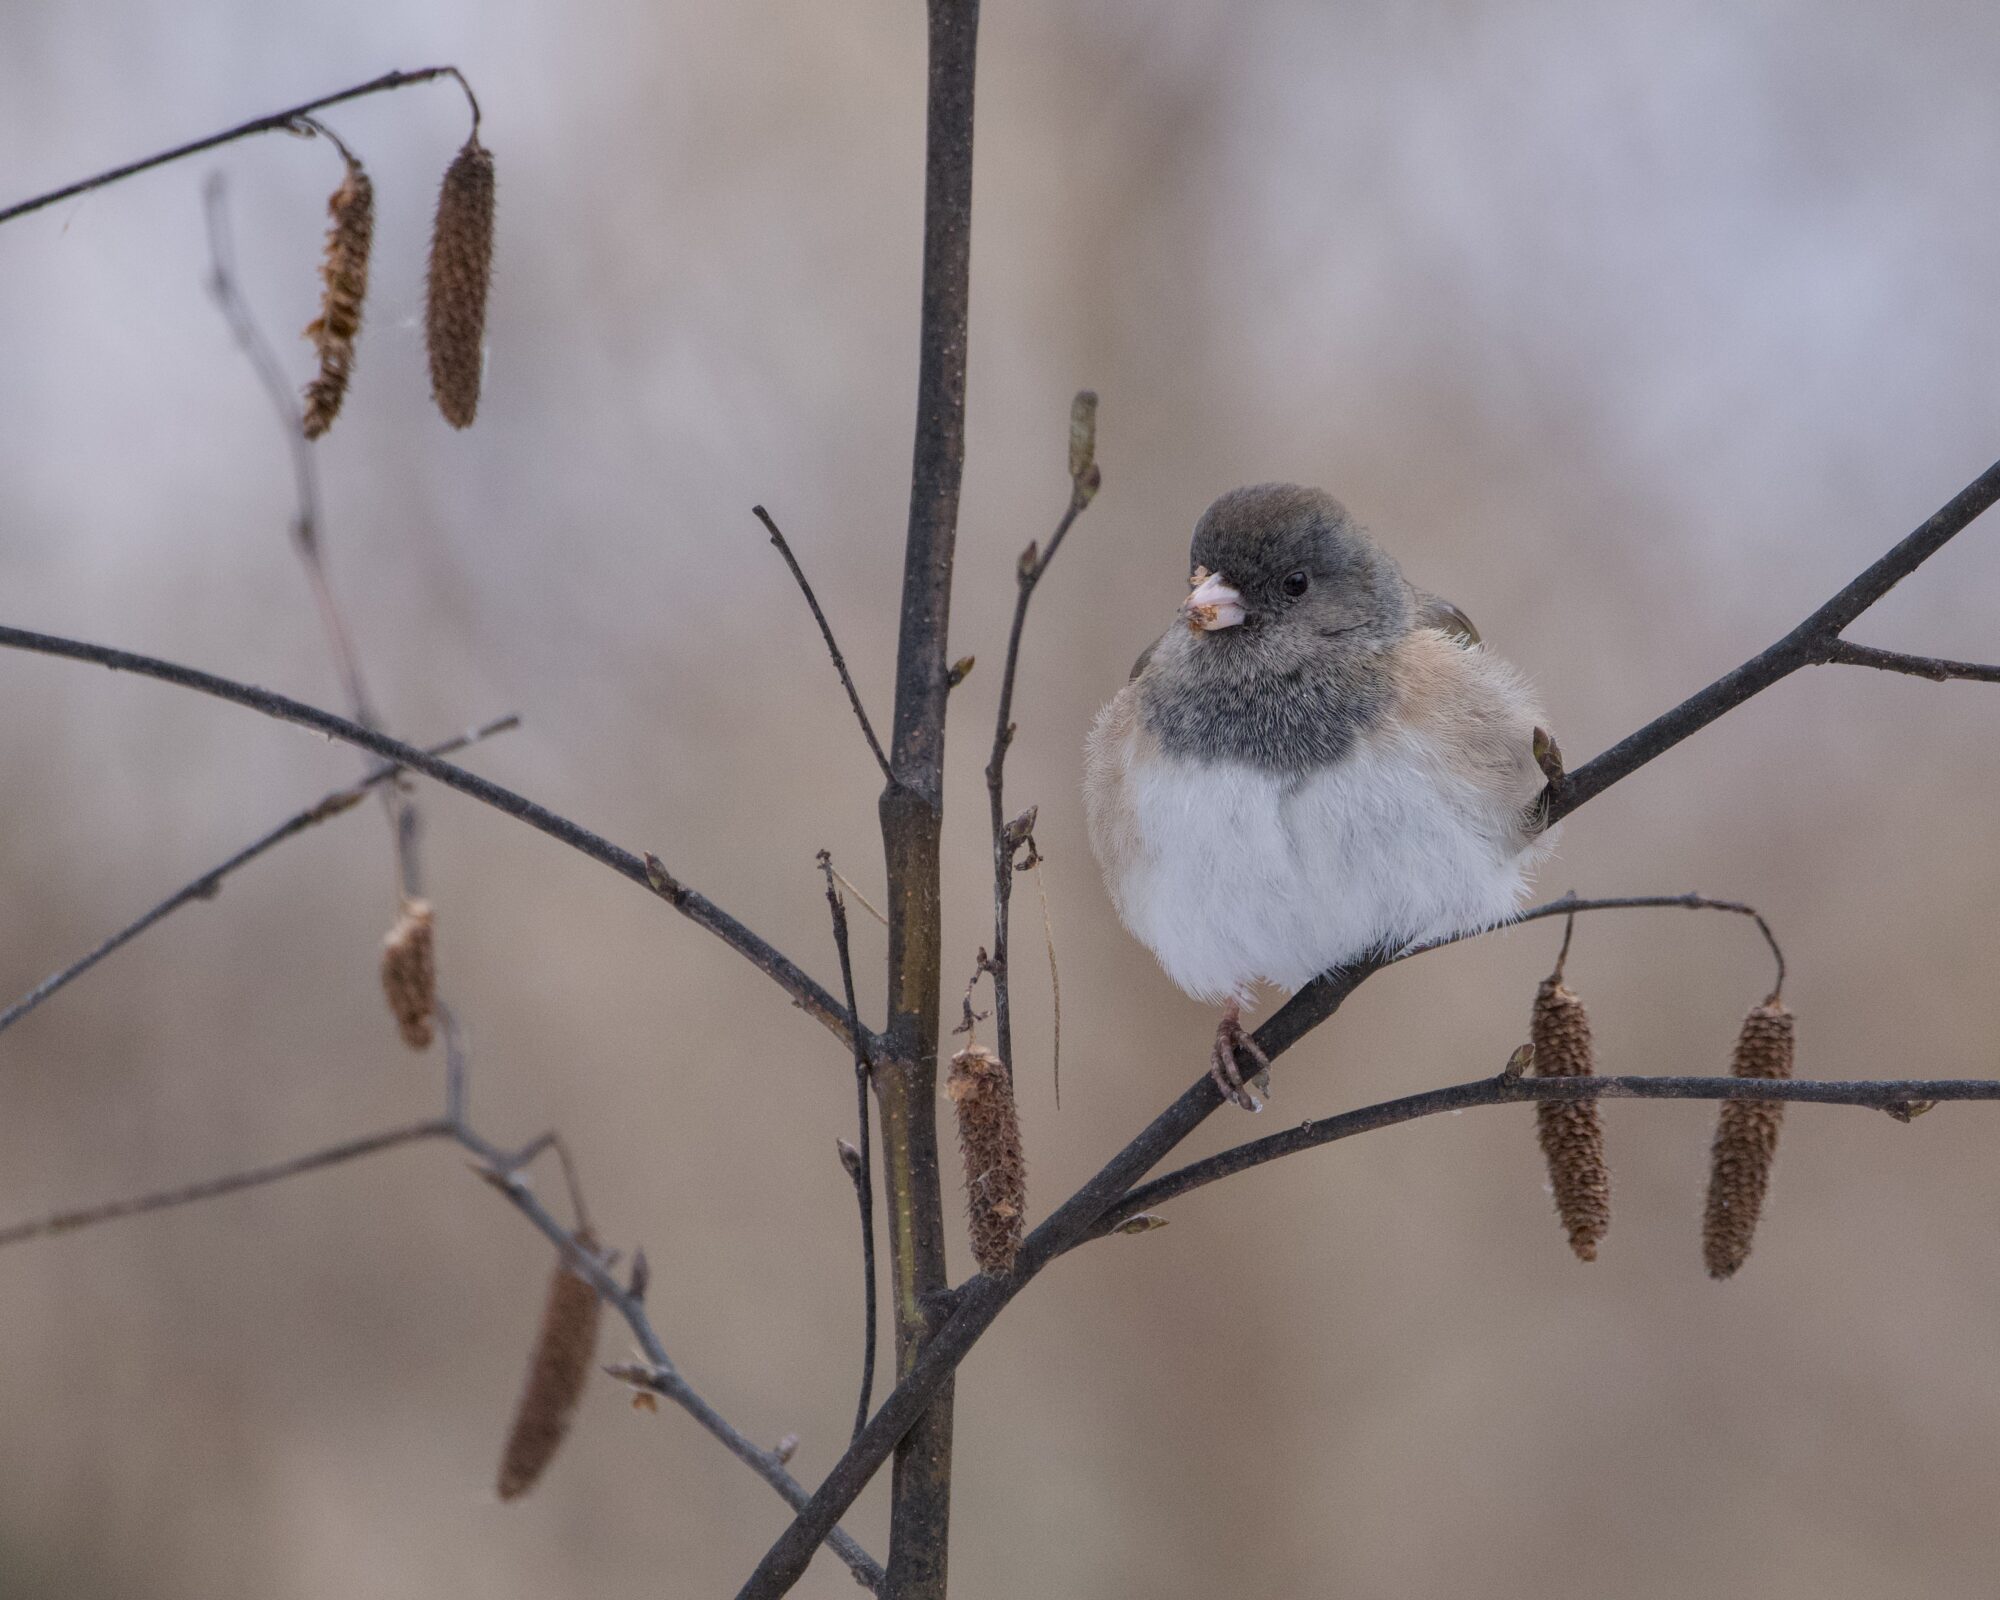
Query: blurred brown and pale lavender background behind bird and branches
0 0 2000 1600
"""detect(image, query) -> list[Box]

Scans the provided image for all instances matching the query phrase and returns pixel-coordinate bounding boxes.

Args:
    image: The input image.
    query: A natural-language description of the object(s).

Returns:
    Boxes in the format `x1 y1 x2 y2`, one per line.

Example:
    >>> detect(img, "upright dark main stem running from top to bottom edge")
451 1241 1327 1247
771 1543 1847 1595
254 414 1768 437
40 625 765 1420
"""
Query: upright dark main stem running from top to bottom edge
876 0 978 1600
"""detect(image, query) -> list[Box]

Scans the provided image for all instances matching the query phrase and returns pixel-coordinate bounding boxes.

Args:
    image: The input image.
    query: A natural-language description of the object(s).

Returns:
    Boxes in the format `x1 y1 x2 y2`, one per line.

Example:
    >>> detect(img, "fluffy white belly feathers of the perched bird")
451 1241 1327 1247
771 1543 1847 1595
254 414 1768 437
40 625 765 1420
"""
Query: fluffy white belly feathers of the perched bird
1090 708 1546 1000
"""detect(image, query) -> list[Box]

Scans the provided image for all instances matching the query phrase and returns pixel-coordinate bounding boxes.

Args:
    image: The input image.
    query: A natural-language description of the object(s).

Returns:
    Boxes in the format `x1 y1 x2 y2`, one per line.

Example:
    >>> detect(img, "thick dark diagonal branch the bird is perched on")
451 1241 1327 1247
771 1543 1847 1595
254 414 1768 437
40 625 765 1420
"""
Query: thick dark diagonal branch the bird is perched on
738 450 2000 1600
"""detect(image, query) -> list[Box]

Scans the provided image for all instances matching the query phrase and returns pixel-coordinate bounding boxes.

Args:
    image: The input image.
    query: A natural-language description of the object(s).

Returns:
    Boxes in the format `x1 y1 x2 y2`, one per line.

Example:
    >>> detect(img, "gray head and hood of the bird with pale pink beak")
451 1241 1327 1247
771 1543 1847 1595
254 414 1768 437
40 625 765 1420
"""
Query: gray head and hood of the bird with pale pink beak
1140 484 1416 772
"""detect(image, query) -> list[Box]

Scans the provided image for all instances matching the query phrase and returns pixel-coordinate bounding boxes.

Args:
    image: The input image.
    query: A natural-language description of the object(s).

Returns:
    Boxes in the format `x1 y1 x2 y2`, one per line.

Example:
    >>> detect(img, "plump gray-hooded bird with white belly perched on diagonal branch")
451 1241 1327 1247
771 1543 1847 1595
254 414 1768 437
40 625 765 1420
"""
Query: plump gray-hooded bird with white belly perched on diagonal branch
1084 484 1558 1110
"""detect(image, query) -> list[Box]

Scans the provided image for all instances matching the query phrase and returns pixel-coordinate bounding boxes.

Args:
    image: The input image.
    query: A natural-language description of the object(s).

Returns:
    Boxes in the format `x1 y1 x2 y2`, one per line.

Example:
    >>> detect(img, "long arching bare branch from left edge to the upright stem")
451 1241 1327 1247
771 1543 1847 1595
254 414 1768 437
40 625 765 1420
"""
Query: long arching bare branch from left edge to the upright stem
0 626 852 1044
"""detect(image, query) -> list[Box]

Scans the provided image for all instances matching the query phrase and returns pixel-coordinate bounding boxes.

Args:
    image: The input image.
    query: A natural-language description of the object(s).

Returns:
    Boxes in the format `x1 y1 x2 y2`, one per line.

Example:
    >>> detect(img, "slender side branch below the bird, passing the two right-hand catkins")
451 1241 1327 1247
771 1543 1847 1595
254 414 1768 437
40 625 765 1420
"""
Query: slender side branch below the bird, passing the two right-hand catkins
1088 1074 2000 1238
